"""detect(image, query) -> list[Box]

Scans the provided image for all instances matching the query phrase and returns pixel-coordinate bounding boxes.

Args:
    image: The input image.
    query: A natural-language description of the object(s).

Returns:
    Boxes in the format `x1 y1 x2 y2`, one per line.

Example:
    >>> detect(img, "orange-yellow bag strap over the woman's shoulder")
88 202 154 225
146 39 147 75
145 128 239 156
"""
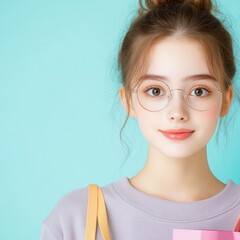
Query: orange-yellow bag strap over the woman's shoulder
85 184 110 240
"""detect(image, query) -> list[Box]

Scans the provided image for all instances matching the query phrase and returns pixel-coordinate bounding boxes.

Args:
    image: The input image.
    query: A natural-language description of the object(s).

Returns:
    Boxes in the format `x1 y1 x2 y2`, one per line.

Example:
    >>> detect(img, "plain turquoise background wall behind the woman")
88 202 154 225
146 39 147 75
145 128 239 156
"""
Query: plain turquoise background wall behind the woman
0 0 240 240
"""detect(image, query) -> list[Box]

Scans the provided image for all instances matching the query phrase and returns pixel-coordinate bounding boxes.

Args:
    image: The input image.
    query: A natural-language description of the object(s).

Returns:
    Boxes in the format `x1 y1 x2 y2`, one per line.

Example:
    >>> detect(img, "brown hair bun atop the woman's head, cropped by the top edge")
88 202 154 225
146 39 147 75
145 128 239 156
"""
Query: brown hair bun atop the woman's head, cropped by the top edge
139 0 212 12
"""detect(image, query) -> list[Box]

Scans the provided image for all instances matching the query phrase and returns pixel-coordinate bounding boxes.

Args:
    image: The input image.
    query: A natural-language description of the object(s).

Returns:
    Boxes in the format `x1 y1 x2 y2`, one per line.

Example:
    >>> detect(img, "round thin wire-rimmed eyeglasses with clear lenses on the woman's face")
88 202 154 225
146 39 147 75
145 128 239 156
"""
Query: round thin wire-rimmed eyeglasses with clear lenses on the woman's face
132 79 222 112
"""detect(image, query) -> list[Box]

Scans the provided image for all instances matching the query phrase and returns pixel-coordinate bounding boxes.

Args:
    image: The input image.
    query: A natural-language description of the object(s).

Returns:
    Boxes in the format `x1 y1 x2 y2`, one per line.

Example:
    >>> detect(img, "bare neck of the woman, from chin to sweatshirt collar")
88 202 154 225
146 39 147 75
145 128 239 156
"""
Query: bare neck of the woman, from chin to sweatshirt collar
130 147 224 202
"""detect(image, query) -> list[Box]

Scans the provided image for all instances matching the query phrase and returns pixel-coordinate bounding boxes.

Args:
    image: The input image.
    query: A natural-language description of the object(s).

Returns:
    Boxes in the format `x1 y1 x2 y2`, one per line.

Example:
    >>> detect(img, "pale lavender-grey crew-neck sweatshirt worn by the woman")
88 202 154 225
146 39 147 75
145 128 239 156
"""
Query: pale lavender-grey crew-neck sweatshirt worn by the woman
41 177 240 240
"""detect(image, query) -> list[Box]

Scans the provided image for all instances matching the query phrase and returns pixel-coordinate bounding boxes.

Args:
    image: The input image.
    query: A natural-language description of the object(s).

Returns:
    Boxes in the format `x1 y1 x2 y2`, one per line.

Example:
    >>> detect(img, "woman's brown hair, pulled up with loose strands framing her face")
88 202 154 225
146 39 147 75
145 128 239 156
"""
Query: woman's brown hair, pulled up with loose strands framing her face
118 0 236 141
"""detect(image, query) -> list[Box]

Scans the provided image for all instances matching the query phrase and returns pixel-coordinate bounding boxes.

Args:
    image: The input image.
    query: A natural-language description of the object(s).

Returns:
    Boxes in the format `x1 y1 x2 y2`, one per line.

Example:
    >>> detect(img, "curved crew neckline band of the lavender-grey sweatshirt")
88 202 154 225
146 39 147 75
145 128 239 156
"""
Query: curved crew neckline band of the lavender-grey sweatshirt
112 177 239 222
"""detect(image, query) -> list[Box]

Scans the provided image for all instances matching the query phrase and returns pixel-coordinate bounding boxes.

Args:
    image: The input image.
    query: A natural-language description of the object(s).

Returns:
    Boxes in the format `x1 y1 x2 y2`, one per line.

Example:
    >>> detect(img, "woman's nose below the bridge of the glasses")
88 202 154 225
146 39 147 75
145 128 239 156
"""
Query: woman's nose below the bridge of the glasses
167 89 189 122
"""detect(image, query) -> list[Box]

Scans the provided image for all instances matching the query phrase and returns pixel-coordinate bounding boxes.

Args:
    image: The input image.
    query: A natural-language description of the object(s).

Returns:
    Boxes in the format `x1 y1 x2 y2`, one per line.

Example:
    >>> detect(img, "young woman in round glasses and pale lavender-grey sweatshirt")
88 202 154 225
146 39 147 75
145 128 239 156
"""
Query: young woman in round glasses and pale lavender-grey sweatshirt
41 0 240 240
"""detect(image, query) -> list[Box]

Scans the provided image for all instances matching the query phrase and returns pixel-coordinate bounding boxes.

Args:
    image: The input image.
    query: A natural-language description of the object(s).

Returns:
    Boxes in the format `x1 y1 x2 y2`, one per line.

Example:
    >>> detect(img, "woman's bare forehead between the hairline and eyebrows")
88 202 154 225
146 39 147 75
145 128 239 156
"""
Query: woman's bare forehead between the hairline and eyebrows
146 37 209 82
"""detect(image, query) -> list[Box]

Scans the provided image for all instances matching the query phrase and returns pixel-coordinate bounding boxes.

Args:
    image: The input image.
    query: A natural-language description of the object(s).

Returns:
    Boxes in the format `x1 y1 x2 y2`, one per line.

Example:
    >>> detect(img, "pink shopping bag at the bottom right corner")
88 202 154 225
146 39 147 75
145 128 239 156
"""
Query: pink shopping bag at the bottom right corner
173 216 240 240
